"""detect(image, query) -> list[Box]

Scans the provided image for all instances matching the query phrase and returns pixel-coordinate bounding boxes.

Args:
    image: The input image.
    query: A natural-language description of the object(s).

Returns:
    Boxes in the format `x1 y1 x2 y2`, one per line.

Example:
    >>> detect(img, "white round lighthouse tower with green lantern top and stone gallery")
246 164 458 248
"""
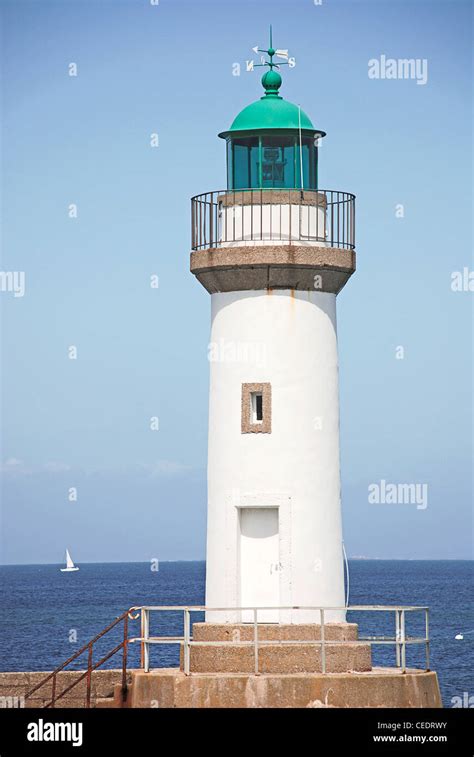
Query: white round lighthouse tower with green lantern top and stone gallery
191 32 355 624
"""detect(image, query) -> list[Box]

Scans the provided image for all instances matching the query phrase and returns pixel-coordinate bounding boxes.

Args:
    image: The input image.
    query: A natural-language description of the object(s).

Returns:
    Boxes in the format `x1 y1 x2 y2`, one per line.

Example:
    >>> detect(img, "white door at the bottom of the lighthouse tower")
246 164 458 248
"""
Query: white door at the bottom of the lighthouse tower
240 507 280 623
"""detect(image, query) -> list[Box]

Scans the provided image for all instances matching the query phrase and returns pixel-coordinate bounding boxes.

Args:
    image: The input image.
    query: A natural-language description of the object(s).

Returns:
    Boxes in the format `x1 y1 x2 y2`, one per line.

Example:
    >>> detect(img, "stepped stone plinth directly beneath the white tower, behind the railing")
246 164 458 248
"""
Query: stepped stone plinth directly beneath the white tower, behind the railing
180 623 372 673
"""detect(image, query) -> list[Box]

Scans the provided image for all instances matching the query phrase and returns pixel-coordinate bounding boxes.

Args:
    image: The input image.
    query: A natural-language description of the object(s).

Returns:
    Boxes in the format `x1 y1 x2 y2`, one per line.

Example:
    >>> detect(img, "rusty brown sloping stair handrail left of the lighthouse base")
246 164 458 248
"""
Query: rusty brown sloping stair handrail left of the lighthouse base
25 607 141 708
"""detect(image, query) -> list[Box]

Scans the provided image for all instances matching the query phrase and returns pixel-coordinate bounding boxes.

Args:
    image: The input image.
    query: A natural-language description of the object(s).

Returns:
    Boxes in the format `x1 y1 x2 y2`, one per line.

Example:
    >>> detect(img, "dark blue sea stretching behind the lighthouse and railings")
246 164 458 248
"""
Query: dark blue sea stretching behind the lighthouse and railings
0 559 474 707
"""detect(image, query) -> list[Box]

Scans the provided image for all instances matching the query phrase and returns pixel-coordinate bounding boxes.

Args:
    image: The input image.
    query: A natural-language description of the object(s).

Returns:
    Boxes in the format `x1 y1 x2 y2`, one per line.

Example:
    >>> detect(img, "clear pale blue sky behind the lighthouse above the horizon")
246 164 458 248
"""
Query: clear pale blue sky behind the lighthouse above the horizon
0 0 473 563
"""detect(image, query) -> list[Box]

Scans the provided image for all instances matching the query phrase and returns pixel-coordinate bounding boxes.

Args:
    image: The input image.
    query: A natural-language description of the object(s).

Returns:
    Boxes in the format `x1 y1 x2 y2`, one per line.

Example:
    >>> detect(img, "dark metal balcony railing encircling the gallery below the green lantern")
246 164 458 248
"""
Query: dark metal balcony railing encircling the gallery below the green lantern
191 189 355 250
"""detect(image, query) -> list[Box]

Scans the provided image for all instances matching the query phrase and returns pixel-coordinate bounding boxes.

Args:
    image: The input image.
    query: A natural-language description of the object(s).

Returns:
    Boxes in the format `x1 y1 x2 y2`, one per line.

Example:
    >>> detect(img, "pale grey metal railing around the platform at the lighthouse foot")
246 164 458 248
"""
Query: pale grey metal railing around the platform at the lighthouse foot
129 605 430 675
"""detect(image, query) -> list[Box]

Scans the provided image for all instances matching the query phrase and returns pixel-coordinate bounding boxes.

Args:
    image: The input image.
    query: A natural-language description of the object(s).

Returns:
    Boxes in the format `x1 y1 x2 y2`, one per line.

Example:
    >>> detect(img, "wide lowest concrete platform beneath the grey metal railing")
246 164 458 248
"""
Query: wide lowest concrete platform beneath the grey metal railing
130 668 442 708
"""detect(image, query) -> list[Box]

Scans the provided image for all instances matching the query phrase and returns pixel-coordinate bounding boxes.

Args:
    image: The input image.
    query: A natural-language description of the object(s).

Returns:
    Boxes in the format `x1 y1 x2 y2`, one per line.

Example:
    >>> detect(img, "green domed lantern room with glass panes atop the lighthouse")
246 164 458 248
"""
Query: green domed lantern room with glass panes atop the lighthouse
219 69 325 190
